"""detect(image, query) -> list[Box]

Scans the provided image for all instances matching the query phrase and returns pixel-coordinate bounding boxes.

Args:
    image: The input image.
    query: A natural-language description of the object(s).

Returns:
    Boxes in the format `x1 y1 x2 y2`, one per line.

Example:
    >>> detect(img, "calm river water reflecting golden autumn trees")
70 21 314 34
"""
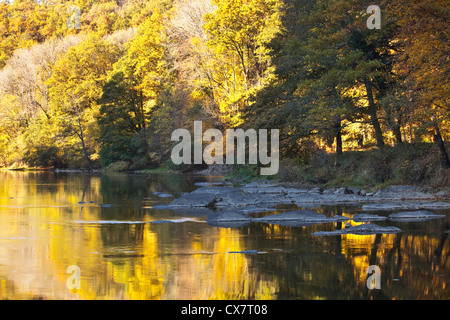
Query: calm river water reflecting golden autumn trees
0 171 450 300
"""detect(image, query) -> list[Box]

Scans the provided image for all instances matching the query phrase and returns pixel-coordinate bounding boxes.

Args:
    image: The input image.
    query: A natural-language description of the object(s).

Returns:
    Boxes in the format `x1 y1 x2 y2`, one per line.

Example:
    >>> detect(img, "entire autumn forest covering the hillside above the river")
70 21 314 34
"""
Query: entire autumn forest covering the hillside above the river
0 0 450 186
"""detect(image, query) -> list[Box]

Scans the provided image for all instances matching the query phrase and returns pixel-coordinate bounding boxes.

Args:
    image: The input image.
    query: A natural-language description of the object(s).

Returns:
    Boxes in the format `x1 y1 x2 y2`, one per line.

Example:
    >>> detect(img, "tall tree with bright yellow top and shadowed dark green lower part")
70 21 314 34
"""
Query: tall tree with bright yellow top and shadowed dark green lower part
98 12 177 168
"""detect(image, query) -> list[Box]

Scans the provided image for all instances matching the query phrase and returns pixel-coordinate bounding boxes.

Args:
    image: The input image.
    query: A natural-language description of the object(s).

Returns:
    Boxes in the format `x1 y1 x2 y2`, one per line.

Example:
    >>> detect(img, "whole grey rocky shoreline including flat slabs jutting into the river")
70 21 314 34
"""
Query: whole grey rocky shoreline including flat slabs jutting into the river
154 182 450 236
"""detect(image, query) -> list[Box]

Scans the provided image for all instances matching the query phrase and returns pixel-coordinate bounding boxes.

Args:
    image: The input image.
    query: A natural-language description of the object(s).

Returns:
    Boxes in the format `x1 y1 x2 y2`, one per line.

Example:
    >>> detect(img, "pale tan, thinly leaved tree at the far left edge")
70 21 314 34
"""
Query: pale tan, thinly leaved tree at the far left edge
0 36 81 166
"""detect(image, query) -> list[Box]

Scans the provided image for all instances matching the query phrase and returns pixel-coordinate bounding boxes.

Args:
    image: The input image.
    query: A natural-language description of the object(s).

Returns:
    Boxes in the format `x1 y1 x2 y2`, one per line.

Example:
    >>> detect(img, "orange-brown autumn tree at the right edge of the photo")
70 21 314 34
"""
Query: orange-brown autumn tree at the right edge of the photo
389 0 450 168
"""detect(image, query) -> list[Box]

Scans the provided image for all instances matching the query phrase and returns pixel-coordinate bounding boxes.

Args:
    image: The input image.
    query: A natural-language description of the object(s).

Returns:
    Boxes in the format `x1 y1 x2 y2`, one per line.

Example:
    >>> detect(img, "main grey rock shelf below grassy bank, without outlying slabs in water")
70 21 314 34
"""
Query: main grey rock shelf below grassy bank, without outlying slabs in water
168 182 450 211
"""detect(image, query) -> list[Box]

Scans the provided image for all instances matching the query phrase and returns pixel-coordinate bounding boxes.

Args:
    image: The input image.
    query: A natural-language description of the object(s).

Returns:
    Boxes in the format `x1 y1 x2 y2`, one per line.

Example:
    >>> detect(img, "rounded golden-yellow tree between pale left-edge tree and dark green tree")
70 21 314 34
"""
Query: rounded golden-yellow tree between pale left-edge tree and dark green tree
48 36 120 163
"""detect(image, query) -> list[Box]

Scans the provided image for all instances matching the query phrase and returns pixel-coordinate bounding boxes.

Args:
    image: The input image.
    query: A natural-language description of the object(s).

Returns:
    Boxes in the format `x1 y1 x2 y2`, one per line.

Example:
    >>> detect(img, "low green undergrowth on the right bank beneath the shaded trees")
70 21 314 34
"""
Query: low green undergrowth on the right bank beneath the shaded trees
286 143 449 188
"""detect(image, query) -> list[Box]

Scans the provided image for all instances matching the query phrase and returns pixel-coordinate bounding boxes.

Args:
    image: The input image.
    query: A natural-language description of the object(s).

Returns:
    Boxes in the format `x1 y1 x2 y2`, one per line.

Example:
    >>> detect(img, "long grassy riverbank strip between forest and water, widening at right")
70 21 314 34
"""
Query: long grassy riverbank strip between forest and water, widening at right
5 143 450 194
